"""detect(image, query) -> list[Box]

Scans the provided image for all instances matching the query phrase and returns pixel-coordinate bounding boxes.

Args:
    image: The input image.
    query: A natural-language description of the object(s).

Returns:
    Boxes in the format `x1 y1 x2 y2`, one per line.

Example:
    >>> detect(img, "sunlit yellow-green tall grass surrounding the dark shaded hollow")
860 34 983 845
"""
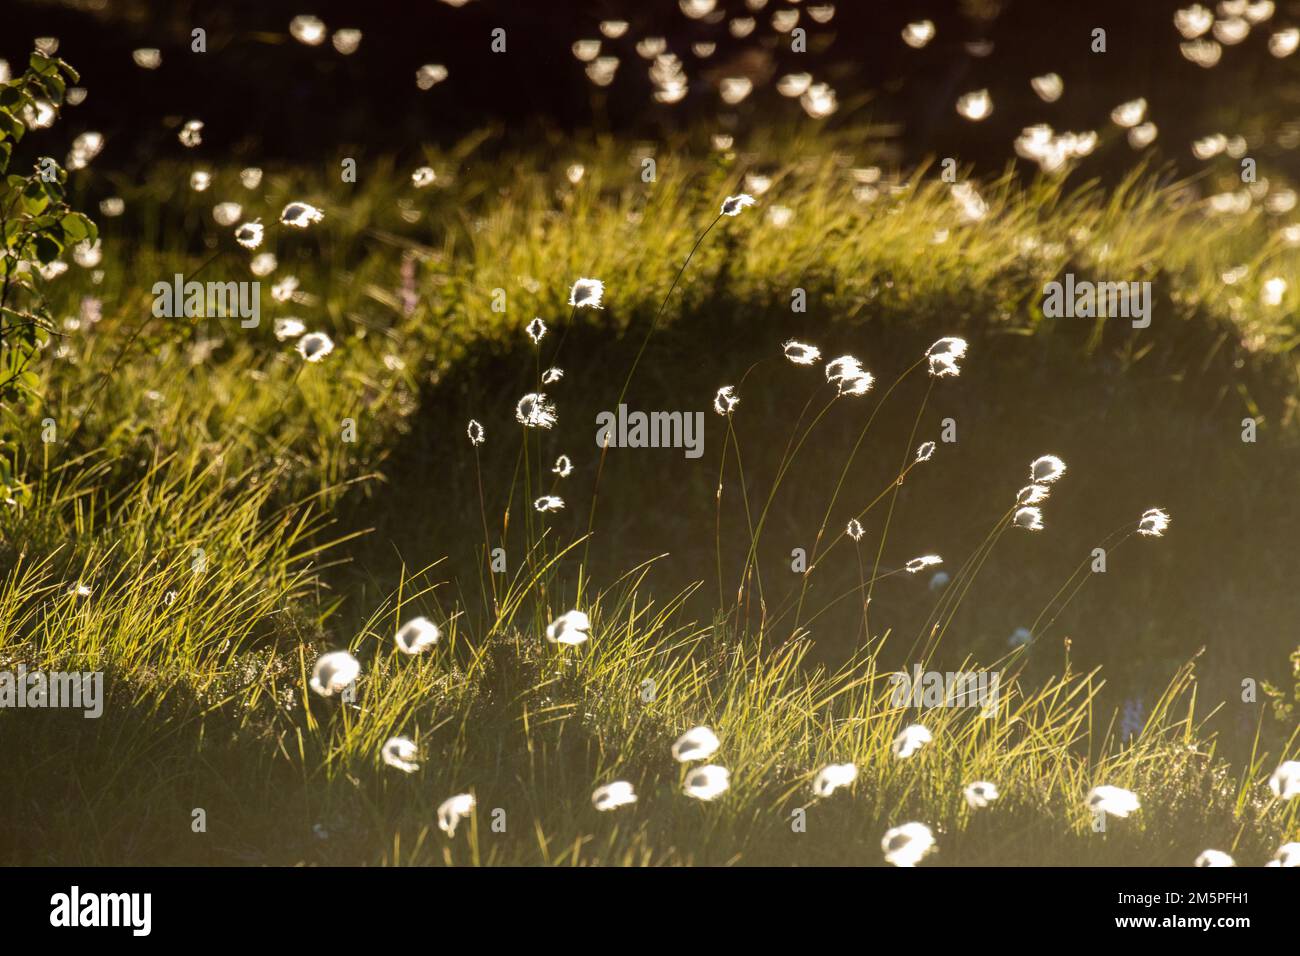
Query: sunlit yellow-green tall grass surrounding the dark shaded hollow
0 128 1300 865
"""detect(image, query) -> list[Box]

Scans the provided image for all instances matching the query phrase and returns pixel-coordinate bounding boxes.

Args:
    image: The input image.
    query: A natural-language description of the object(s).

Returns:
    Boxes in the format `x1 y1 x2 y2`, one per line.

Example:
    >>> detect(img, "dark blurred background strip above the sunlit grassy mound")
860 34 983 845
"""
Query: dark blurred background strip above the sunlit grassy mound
10 0 1300 176
